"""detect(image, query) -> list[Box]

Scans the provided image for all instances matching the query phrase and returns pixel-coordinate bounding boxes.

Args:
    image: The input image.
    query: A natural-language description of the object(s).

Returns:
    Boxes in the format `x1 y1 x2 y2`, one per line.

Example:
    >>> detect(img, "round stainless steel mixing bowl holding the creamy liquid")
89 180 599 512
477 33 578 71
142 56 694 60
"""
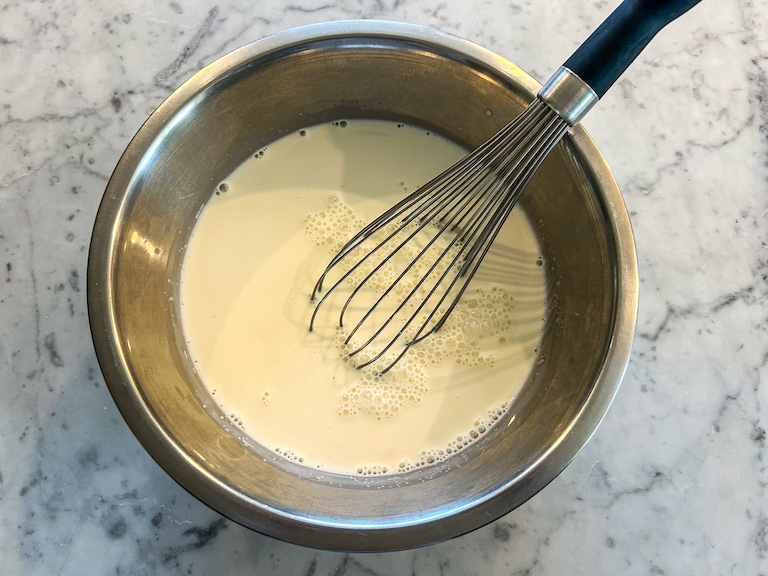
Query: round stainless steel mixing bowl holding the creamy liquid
88 21 637 550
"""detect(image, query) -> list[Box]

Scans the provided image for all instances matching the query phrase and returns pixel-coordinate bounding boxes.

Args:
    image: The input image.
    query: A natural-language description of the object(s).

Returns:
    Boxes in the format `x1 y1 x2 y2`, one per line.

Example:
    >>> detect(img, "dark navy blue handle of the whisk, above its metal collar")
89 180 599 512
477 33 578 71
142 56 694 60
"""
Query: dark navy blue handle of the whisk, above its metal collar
564 0 701 98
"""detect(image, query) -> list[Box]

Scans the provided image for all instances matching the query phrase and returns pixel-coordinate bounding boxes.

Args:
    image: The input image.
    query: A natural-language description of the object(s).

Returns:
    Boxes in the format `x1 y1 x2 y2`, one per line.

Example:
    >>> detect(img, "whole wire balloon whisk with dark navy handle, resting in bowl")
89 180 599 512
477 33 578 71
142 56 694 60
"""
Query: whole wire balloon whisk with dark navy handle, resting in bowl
309 0 700 374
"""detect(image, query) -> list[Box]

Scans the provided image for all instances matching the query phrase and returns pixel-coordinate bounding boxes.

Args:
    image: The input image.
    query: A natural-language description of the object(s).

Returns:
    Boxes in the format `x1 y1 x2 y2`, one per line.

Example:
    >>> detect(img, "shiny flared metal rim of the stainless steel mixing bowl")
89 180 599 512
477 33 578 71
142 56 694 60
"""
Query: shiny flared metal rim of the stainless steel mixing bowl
87 20 638 551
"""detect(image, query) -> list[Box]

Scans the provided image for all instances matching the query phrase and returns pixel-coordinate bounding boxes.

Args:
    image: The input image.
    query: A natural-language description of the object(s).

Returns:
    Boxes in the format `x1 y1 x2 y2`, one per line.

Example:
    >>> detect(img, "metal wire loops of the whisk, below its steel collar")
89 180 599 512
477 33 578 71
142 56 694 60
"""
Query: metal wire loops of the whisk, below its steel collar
309 99 568 374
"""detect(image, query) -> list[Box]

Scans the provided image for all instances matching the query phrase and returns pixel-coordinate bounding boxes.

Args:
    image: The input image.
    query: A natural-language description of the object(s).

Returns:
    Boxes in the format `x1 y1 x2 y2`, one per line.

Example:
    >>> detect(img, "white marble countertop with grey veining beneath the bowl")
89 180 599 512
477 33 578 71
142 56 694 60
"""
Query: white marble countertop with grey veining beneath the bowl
0 0 768 576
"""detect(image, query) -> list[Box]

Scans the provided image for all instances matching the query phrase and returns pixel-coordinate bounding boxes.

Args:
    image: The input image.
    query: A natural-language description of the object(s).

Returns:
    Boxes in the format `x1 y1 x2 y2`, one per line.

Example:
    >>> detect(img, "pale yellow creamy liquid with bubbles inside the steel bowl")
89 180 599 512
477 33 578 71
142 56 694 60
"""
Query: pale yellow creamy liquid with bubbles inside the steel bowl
181 120 545 474
